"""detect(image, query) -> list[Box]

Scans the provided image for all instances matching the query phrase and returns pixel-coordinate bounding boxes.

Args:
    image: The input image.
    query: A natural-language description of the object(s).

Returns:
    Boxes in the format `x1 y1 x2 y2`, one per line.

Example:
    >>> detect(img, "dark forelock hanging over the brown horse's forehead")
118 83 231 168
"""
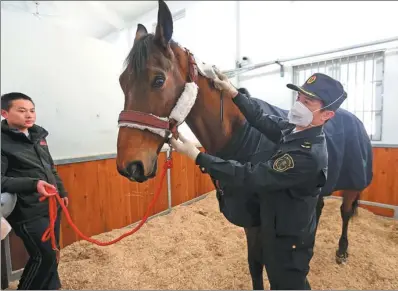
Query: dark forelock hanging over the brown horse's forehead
124 33 178 74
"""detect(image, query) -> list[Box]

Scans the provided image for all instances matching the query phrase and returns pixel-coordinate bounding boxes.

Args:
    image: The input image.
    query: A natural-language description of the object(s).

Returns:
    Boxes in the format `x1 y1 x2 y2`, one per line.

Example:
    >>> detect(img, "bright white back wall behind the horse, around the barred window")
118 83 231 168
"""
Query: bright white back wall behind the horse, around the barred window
103 1 398 145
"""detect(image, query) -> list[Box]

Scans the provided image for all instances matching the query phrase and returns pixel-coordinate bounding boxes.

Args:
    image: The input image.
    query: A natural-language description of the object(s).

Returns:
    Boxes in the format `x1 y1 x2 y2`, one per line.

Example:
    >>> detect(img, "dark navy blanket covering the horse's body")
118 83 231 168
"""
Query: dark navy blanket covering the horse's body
216 98 373 227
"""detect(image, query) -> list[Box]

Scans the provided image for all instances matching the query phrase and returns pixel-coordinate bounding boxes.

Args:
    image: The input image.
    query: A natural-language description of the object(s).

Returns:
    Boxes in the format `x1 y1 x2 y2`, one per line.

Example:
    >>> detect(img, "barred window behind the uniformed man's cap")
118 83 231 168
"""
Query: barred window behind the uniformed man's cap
293 51 384 141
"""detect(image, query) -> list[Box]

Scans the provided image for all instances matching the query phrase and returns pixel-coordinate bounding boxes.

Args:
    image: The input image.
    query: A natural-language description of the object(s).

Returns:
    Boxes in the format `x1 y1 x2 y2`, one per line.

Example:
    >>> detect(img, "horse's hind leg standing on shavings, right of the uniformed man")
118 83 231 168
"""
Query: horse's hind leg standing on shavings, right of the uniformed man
336 191 361 264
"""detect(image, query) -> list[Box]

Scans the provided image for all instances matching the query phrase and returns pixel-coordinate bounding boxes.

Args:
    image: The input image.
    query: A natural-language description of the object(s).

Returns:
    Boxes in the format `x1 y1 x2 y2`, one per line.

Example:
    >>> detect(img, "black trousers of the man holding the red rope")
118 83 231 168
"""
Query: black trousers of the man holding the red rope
13 213 61 290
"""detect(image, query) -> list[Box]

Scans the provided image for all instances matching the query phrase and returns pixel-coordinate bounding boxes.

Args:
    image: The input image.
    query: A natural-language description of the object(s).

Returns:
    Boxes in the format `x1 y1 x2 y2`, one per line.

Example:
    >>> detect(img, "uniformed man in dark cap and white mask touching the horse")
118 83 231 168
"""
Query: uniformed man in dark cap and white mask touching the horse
171 72 347 290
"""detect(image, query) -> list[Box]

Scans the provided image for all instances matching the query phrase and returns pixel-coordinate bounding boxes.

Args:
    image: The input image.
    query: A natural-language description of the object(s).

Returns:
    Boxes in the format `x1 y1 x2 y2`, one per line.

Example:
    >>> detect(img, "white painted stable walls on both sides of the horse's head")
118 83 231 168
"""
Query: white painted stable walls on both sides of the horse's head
1 1 398 163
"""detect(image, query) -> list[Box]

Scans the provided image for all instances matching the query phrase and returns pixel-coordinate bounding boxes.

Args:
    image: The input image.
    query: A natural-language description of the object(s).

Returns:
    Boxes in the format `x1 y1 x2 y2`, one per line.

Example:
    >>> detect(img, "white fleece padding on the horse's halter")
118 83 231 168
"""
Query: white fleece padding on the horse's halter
119 82 198 137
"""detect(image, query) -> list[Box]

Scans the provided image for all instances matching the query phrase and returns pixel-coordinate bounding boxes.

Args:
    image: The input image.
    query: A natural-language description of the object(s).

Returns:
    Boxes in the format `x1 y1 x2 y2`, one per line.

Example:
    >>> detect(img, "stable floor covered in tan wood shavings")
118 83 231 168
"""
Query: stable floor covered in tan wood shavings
6 193 398 290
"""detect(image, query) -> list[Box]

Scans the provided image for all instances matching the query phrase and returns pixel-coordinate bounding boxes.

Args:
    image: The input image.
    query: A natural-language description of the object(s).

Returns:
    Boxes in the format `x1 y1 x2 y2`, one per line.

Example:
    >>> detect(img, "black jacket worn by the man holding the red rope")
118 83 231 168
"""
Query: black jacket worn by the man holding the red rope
1 120 67 223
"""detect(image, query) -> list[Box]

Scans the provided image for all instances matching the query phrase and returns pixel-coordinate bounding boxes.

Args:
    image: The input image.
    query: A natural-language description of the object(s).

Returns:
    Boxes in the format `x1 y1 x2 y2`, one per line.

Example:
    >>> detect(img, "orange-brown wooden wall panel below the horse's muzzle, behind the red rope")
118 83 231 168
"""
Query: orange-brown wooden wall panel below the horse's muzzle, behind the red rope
57 153 168 246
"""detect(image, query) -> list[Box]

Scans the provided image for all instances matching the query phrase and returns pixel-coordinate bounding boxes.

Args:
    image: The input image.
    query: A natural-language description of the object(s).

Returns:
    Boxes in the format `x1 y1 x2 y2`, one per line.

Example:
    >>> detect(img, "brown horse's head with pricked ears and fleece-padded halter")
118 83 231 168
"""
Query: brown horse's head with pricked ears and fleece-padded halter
116 1 244 182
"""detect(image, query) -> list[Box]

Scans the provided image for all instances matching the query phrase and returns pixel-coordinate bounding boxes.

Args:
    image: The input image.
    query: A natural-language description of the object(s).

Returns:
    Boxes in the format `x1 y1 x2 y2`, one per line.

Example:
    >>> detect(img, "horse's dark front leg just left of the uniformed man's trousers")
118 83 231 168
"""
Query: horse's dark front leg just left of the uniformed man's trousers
245 227 264 290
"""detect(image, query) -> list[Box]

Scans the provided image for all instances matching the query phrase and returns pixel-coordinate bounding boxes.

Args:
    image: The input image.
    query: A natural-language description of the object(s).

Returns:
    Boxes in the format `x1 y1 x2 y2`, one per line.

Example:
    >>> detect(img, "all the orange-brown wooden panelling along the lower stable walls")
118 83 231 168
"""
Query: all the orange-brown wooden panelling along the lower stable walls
46 148 398 246
